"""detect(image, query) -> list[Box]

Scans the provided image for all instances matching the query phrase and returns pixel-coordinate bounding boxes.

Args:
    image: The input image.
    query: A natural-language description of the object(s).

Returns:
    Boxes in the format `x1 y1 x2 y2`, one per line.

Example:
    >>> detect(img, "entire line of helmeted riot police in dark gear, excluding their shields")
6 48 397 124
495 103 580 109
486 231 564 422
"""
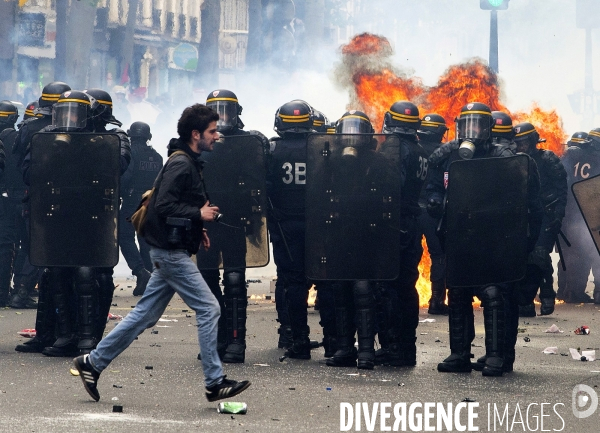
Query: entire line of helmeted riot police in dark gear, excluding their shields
0 82 600 376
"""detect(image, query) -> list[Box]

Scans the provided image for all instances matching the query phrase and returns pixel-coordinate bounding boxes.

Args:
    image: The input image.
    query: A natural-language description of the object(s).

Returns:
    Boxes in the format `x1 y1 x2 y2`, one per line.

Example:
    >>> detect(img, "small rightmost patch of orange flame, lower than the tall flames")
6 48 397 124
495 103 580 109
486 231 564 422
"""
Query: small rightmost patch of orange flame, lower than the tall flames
512 104 568 156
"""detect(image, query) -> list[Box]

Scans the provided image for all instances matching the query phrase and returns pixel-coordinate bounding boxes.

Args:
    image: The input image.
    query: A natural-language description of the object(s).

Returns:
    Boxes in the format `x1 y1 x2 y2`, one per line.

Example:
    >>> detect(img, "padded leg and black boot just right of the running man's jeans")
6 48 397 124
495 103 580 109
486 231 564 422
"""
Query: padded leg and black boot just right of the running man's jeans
223 272 248 364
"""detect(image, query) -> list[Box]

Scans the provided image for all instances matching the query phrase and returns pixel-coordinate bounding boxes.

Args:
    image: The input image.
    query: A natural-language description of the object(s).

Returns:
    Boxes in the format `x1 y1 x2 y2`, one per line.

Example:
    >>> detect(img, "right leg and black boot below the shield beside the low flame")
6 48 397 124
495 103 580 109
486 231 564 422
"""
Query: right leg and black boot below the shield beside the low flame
481 286 506 376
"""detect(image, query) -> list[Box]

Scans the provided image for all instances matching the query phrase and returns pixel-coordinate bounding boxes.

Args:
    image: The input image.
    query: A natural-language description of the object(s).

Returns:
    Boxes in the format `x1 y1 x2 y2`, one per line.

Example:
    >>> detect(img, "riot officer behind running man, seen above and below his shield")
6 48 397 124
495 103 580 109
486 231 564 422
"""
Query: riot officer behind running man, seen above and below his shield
197 89 269 363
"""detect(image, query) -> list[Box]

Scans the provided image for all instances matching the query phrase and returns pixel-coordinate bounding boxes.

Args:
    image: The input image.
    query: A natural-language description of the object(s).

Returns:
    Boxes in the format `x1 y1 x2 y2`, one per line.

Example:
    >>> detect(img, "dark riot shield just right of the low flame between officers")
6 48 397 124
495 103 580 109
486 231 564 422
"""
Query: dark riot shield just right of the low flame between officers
445 155 529 287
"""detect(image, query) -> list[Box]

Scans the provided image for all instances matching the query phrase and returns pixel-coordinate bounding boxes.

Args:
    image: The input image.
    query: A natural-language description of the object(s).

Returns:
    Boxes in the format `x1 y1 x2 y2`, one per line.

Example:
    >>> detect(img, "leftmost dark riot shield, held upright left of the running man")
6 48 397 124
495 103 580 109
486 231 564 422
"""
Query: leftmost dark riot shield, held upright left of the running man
30 132 120 267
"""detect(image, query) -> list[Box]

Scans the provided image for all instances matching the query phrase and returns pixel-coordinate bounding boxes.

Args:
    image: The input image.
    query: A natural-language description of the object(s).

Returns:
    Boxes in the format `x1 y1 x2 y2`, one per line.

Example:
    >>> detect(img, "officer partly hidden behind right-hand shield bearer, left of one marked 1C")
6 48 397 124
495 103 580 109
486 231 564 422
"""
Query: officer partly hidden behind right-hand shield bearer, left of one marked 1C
514 122 567 317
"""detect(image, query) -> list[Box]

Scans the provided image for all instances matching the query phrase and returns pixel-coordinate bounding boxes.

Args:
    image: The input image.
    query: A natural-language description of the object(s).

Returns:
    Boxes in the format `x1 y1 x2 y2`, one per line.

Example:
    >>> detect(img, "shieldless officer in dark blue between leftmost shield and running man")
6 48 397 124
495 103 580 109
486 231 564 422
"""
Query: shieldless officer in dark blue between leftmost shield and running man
119 122 163 296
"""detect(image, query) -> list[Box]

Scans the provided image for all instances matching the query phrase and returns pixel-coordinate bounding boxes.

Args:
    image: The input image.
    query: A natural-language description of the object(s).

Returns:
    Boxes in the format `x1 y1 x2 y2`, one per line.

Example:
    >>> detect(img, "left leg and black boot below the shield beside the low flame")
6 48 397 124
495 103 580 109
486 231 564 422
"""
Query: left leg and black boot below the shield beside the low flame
438 288 474 373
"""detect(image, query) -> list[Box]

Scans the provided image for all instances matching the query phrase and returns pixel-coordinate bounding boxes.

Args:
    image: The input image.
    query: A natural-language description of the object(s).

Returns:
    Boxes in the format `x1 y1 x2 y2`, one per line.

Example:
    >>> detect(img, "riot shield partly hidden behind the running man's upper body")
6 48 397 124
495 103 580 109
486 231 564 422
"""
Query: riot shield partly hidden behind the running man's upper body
196 134 269 269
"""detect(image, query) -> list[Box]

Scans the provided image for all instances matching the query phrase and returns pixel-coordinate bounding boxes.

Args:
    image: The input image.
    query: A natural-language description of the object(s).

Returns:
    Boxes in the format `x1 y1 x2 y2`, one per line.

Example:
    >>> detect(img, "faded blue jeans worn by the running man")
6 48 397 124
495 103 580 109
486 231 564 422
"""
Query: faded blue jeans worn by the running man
90 248 223 387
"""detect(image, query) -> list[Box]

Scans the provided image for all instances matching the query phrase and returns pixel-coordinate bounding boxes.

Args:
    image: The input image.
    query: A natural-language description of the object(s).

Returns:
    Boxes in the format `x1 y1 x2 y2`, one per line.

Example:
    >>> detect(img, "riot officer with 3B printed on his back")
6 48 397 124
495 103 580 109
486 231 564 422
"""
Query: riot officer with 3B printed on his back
267 101 313 359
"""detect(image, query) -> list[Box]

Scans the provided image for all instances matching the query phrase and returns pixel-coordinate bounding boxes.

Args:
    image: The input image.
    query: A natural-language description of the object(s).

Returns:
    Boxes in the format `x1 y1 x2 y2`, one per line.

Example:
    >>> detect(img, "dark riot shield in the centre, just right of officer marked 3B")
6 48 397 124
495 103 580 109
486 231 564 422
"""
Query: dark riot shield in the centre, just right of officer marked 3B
305 134 401 280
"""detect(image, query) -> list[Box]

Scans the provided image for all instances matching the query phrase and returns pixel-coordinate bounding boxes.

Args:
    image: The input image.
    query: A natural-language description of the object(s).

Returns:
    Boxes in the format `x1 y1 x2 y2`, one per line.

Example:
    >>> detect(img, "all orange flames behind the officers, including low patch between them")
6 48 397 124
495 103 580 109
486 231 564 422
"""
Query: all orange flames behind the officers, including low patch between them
336 33 567 306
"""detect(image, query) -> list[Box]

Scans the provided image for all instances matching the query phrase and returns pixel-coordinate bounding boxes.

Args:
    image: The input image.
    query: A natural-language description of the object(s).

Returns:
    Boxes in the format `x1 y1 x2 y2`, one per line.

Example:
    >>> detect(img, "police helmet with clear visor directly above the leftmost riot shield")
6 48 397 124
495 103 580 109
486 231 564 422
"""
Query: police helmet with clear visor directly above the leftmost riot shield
52 90 97 132
